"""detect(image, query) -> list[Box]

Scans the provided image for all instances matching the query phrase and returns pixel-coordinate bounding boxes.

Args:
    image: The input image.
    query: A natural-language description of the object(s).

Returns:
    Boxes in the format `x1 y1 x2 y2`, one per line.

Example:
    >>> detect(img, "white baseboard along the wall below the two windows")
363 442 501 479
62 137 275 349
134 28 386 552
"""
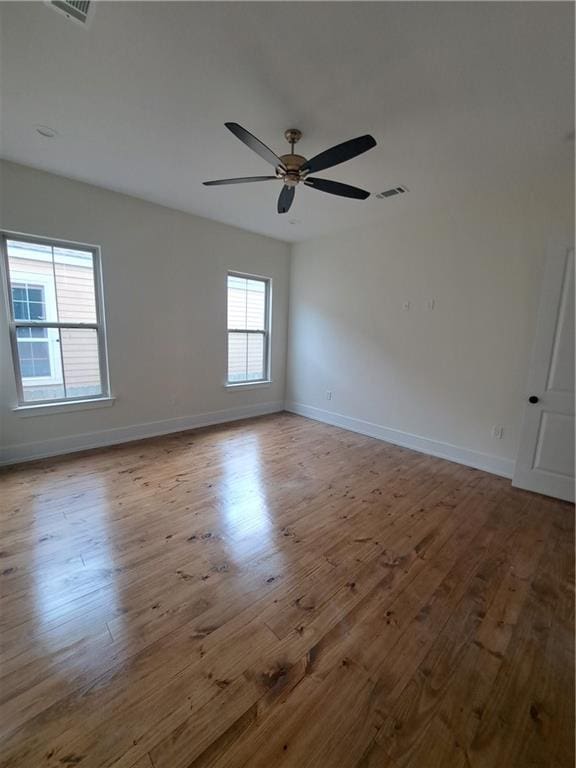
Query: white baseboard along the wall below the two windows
0 402 284 466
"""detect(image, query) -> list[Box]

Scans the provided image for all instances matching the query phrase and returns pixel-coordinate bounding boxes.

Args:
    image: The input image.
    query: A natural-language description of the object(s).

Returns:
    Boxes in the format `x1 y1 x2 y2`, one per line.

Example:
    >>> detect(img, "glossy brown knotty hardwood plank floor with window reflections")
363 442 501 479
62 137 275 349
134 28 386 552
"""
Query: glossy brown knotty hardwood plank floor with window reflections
0 414 574 768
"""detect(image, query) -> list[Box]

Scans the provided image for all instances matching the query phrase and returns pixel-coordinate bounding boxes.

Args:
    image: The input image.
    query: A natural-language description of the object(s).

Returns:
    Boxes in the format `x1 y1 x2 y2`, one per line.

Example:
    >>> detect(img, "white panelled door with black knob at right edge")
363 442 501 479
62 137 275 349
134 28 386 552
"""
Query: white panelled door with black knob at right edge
512 247 574 501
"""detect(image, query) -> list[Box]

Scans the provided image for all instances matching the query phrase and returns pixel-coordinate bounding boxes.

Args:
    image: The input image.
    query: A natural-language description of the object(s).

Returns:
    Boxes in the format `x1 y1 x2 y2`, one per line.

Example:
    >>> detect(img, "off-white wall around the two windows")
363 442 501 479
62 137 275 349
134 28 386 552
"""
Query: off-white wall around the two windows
0 162 290 461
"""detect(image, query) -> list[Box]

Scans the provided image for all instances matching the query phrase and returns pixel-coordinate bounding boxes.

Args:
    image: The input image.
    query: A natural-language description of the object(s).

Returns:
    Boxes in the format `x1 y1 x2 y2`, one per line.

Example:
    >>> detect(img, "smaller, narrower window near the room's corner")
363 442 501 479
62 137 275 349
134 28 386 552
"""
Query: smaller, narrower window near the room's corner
228 273 270 384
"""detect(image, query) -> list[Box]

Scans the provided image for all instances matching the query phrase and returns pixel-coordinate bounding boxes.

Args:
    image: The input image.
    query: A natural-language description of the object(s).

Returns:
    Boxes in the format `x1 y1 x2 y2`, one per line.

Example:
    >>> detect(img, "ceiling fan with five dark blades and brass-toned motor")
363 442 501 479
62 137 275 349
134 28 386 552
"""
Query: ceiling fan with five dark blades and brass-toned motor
204 123 376 213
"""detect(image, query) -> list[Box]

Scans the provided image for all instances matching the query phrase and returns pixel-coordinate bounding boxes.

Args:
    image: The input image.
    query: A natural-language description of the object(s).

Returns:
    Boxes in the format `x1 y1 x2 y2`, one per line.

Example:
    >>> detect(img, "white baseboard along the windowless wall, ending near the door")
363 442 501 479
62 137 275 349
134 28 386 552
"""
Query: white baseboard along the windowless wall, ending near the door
284 402 514 478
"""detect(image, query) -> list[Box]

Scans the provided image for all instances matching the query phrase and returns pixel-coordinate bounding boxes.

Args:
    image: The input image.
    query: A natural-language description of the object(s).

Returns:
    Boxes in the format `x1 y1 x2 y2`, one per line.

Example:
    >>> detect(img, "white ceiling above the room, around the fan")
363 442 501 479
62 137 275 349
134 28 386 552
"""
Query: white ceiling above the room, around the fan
0 2 573 241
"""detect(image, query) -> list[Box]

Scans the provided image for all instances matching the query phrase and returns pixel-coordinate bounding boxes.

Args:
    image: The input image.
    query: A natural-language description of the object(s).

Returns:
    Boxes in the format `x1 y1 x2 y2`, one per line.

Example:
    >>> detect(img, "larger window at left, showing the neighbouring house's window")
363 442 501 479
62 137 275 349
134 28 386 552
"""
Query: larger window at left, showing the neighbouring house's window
2 234 108 405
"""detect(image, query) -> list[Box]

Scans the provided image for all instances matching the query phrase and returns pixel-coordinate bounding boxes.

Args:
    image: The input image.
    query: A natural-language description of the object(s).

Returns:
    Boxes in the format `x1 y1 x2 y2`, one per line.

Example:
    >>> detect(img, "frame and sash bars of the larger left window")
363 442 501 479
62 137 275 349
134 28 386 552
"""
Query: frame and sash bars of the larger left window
0 230 110 409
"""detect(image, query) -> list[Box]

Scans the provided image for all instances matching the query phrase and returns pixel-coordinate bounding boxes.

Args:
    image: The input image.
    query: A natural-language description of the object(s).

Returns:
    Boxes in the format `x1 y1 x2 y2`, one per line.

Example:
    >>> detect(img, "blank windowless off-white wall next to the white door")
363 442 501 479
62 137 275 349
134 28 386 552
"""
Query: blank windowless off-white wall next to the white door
287 160 574 475
